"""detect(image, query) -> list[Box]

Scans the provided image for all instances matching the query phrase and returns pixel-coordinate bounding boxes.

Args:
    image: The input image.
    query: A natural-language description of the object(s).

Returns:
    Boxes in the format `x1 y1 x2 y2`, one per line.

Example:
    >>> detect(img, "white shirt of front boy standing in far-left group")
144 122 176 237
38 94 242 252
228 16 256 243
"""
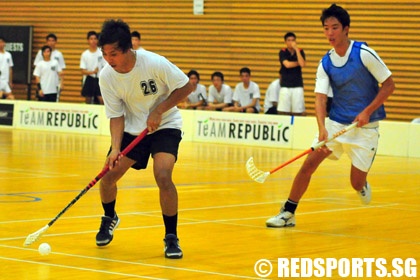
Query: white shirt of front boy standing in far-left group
34 59 62 94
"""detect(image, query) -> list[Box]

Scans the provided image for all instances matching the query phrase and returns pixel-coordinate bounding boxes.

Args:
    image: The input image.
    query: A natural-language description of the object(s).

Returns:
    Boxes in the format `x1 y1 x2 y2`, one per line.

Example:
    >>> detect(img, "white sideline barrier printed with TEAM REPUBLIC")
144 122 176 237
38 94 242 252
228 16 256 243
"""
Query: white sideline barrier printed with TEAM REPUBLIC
0 100 420 157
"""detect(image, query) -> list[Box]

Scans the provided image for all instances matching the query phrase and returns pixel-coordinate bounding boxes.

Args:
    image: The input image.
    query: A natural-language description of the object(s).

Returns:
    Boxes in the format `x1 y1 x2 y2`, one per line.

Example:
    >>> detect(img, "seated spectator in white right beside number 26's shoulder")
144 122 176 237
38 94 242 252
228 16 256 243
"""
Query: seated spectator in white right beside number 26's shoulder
178 70 207 110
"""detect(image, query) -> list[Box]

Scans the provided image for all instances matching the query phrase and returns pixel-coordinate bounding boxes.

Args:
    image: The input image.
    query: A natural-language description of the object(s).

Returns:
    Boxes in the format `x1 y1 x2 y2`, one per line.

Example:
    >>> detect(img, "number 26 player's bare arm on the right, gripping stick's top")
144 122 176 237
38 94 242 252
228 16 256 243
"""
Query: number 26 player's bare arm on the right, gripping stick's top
147 82 193 131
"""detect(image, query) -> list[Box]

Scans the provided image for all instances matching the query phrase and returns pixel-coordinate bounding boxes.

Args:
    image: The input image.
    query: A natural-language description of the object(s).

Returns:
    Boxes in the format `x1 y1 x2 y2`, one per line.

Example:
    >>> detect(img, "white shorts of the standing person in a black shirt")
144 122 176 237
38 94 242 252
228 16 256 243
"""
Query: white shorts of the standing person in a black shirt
277 87 305 113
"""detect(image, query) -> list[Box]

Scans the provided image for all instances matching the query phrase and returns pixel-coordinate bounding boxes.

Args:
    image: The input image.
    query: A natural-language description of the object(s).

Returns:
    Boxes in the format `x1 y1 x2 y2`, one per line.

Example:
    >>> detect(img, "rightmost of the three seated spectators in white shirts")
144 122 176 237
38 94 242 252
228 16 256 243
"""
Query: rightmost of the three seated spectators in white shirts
223 67 261 113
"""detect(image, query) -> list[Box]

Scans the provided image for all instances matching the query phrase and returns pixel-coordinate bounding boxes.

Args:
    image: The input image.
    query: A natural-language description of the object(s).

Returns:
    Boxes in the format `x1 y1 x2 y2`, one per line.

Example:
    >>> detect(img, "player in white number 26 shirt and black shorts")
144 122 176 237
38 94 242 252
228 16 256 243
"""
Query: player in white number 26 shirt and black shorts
96 20 192 259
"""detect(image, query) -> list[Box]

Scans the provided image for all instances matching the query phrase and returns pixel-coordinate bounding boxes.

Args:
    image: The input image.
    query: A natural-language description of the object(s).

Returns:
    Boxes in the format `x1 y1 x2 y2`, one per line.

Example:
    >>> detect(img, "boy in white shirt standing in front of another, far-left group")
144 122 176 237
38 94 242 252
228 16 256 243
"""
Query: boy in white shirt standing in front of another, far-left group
34 46 63 102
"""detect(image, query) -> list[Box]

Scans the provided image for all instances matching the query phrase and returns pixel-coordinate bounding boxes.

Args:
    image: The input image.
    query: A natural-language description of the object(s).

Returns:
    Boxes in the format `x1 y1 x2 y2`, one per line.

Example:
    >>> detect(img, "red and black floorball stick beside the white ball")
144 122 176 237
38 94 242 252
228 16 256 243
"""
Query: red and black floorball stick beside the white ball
23 128 148 246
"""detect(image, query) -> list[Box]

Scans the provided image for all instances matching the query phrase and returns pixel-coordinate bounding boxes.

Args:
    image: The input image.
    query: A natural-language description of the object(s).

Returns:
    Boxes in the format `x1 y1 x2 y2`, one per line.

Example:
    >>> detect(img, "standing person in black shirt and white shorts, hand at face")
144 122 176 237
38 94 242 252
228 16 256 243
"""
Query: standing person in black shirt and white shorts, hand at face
277 32 306 115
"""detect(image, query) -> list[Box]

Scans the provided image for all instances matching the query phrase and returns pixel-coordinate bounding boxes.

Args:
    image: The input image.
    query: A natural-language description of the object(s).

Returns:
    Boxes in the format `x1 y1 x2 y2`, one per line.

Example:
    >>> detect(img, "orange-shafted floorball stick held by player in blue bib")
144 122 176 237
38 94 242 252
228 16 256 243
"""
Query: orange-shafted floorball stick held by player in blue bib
245 123 357 184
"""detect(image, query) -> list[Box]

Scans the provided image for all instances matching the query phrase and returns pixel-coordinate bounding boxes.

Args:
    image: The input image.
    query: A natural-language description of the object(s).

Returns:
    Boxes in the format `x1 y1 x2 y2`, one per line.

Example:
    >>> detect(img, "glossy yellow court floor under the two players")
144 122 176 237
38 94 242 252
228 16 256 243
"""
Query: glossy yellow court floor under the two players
0 129 420 280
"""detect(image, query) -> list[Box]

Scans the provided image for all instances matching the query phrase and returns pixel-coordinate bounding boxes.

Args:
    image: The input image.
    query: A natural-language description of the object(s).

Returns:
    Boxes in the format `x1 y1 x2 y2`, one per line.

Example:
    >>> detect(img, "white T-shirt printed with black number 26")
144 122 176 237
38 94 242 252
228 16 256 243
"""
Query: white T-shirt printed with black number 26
99 51 189 135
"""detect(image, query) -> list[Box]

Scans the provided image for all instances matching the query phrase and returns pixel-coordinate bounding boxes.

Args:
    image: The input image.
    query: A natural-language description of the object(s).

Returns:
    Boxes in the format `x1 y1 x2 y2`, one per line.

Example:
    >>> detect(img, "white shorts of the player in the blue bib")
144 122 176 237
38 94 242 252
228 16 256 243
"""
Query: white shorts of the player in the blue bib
313 120 379 172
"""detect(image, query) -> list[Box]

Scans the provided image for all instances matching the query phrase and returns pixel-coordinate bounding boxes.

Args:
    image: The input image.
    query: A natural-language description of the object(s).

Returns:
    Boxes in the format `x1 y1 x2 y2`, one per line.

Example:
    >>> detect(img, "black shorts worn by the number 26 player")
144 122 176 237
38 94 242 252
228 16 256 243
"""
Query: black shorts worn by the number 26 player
109 128 182 170
